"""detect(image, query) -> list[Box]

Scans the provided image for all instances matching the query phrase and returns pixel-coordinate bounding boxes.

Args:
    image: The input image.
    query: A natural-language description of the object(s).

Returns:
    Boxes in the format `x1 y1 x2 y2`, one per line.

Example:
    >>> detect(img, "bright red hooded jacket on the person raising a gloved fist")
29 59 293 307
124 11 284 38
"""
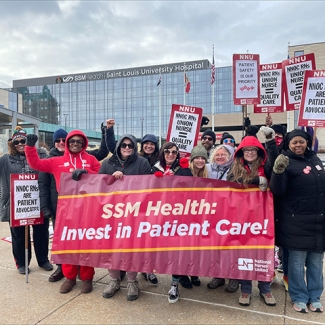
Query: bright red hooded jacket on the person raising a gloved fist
25 130 100 192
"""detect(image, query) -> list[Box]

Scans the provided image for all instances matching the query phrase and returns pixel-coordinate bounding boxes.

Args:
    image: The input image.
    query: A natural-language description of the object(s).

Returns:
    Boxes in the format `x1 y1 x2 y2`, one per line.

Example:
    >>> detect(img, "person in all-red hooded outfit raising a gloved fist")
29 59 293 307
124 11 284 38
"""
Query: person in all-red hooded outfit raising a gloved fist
25 130 100 294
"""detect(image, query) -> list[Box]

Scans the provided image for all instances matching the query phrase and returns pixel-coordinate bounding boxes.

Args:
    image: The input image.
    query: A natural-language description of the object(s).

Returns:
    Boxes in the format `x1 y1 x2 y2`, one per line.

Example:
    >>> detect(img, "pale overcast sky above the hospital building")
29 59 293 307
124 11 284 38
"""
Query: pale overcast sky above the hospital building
0 0 325 88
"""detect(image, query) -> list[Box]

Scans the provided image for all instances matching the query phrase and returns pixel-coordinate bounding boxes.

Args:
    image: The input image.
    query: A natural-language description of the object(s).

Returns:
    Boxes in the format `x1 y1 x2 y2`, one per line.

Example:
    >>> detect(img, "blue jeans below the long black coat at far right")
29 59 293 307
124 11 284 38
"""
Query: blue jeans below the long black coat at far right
288 249 324 304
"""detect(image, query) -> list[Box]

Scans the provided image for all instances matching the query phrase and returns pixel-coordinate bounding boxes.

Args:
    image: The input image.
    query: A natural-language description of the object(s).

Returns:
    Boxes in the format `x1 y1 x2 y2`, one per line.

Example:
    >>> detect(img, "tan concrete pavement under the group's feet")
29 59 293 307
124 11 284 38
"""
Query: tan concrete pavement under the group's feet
0 223 325 325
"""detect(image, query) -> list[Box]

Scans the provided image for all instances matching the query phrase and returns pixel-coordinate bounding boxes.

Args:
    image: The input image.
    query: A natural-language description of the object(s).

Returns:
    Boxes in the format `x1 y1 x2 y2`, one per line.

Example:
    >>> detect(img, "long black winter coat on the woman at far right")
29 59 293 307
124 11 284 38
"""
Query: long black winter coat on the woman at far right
270 150 325 253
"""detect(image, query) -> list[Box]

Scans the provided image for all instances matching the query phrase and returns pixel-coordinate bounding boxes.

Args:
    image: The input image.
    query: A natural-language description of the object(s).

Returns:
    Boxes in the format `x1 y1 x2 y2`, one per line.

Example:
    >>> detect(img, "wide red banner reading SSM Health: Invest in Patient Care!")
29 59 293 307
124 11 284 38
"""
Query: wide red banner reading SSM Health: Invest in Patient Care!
52 174 274 281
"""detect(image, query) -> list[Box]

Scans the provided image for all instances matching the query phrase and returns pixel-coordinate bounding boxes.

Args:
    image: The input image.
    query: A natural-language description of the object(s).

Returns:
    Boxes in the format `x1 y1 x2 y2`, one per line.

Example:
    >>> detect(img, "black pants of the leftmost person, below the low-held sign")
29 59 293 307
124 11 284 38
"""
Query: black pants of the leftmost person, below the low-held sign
10 218 49 268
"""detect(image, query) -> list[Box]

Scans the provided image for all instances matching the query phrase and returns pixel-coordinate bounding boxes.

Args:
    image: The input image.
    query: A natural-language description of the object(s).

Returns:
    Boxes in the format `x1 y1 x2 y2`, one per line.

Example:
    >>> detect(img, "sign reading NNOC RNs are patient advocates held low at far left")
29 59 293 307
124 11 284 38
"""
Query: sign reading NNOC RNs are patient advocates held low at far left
10 174 44 227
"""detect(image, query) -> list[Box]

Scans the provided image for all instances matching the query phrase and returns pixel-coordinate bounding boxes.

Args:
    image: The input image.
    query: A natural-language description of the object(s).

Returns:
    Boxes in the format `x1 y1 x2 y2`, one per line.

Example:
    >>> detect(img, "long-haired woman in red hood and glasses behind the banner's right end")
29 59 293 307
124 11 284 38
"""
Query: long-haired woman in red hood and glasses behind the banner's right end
227 136 276 306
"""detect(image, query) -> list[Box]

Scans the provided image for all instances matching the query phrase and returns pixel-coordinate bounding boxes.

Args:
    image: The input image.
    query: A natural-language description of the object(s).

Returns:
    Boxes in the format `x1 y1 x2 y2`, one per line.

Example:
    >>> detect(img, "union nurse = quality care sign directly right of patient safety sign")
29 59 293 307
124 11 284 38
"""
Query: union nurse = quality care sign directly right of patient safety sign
254 62 284 113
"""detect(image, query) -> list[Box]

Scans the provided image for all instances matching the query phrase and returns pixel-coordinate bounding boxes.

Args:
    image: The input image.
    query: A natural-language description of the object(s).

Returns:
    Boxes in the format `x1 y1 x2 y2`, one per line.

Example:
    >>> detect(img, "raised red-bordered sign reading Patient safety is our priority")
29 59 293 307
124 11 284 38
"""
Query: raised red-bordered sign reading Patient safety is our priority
232 54 260 105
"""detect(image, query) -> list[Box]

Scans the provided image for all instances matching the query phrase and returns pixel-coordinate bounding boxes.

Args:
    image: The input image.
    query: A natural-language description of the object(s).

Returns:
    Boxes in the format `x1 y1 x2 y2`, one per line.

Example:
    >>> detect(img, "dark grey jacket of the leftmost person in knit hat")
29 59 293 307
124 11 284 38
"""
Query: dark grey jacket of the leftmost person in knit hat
0 148 47 221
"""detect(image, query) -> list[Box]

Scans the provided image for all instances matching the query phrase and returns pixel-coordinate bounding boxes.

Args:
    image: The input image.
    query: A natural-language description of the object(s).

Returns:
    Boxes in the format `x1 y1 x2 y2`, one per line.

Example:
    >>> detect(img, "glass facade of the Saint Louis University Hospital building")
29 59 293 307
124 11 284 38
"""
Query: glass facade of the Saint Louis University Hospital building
14 60 242 138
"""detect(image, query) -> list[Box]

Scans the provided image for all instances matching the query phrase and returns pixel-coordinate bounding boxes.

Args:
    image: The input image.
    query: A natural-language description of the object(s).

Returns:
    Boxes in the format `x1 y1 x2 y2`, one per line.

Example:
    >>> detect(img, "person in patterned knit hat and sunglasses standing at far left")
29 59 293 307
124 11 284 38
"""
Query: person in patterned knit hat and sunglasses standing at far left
0 126 53 274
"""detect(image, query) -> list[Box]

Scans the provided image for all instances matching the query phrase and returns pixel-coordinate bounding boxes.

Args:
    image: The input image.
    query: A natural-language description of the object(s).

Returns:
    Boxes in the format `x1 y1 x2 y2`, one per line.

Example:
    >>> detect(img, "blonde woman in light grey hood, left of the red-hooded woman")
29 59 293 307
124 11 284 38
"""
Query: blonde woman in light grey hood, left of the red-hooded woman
207 144 239 292
